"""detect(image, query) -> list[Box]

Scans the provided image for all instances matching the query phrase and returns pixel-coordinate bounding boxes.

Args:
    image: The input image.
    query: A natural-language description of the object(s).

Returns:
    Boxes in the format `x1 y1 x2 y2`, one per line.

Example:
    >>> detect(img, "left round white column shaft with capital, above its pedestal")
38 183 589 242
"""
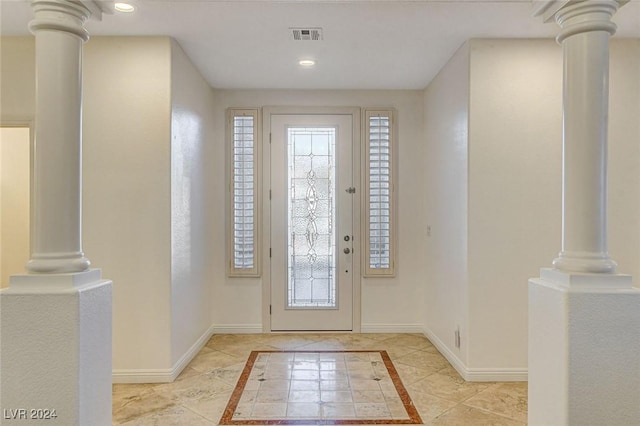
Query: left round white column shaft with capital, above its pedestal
27 0 91 273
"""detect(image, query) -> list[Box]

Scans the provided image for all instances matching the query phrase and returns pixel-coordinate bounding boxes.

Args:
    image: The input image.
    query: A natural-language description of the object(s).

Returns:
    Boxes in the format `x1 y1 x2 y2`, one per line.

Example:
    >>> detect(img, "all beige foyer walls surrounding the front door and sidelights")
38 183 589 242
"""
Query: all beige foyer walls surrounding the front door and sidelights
0 33 640 376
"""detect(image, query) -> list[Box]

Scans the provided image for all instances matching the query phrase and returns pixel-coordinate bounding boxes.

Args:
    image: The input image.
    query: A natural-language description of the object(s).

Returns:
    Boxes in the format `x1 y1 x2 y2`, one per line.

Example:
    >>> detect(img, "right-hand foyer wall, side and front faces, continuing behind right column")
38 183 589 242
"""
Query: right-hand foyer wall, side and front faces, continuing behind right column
425 40 640 380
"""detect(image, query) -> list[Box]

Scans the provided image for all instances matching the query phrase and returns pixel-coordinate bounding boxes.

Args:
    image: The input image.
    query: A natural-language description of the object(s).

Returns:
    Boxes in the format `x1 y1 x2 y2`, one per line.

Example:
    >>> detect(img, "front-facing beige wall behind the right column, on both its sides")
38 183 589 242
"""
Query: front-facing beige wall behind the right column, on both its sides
469 39 640 369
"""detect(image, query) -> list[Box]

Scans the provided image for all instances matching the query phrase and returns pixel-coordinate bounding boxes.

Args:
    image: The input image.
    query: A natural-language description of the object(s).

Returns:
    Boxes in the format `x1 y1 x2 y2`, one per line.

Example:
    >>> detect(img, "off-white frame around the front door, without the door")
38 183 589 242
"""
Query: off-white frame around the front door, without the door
260 107 362 333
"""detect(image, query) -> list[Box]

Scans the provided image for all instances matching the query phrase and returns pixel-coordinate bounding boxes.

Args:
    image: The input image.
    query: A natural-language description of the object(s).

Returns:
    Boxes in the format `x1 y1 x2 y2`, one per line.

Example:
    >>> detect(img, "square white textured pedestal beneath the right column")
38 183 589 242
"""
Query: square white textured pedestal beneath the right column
528 269 640 426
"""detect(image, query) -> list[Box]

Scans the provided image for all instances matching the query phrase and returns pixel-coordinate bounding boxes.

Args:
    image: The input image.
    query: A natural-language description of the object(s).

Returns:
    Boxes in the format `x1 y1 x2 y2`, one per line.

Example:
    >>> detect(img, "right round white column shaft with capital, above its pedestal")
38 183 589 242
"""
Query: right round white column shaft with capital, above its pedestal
553 0 621 272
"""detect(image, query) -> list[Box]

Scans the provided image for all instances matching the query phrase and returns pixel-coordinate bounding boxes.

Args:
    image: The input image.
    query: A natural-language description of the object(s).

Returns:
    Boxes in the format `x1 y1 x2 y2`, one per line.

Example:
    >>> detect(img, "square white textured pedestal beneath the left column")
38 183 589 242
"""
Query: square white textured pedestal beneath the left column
0 270 112 426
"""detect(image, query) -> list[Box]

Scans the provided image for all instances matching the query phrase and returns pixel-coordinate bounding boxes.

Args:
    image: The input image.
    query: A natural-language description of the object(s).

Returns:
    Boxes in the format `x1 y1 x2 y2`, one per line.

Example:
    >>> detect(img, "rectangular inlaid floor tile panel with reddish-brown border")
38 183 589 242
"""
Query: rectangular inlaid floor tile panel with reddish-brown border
220 350 422 425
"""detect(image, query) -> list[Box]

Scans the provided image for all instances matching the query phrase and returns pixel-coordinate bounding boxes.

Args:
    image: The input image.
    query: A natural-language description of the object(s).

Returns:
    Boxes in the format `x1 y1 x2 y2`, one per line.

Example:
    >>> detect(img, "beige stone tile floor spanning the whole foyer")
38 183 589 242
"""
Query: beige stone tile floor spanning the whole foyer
113 334 527 426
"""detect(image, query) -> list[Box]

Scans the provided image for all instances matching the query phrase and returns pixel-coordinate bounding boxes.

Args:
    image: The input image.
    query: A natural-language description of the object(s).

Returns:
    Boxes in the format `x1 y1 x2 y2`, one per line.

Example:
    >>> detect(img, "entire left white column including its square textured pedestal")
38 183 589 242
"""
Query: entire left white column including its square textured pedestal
0 0 112 426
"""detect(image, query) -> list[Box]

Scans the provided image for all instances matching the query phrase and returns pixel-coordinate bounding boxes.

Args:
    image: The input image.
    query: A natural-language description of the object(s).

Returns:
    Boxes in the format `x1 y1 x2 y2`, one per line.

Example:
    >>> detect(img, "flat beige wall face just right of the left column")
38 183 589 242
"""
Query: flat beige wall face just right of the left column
83 37 172 371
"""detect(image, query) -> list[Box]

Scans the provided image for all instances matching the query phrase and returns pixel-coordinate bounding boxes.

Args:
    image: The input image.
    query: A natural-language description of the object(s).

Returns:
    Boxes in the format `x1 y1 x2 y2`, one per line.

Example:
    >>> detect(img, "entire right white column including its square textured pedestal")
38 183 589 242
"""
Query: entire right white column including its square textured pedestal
528 0 640 426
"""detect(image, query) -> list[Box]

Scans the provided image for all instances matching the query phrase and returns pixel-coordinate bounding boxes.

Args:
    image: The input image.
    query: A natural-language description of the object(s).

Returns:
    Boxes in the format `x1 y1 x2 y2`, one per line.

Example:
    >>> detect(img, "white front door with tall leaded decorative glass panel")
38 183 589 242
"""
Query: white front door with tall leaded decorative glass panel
265 113 357 331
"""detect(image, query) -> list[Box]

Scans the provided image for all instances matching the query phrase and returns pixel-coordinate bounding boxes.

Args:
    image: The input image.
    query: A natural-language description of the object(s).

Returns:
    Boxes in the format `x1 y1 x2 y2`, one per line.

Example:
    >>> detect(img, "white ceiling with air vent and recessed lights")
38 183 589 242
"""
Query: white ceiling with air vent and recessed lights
0 0 640 89
